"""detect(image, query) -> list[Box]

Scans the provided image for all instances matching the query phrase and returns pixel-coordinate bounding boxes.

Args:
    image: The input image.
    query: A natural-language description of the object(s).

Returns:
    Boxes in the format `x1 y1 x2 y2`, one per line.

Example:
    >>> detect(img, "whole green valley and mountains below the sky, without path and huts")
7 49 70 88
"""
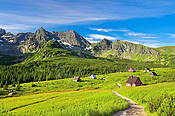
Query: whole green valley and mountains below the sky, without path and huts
0 28 175 116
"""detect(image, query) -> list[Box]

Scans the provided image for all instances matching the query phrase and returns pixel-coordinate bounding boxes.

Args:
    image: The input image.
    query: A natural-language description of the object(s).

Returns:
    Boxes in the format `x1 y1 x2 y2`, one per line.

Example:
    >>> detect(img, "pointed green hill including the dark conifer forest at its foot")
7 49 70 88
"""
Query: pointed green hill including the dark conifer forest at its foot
0 40 165 86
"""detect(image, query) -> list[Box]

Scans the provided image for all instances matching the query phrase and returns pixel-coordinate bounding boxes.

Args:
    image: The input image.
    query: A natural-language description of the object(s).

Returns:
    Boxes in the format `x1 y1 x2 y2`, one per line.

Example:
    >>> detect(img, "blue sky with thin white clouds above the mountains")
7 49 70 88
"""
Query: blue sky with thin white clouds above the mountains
0 0 175 47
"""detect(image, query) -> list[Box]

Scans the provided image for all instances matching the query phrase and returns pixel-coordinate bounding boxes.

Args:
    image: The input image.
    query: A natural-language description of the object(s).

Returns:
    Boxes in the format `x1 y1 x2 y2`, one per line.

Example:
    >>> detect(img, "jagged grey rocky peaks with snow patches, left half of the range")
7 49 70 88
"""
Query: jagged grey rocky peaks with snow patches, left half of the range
0 27 90 55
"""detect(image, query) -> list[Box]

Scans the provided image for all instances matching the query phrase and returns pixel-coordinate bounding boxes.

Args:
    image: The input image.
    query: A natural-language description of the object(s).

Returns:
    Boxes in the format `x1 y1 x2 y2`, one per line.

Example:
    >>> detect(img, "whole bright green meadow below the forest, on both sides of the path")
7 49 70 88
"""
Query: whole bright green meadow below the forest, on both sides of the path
0 68 175 116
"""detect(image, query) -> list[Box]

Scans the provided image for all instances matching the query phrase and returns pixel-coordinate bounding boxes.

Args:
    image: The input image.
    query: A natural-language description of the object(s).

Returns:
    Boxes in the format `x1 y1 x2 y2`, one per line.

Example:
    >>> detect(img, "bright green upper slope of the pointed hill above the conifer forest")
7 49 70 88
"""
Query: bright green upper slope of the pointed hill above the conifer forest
25 40 94 62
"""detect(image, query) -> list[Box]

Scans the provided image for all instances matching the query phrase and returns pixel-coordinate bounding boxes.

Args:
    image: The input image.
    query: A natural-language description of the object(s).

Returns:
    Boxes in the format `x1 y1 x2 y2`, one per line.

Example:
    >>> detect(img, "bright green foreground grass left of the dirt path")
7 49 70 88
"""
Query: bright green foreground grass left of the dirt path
0 90 129 116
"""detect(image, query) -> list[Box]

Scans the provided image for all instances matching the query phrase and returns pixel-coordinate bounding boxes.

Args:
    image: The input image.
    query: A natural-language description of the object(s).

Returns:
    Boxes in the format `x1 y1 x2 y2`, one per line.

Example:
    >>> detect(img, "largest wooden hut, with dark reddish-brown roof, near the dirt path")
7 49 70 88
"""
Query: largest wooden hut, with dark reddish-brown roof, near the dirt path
126 76 143 86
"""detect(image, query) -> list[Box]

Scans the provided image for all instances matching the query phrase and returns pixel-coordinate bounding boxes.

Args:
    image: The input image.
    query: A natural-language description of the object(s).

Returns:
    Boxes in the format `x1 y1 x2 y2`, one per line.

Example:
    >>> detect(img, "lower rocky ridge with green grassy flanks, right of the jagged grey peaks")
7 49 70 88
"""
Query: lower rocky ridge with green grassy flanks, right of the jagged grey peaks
91 39 160 61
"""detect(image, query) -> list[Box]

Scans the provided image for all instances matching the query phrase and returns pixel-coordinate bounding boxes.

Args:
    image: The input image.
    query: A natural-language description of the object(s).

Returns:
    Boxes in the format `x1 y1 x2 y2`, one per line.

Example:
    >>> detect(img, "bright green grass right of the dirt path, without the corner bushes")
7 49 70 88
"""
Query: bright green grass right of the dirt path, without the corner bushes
117 82 175 116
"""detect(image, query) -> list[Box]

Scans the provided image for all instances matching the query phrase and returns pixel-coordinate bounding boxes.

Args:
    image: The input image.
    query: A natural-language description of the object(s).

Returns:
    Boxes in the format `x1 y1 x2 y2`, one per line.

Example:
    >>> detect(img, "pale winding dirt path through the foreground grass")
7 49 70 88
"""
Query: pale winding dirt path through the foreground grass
112 91 147 116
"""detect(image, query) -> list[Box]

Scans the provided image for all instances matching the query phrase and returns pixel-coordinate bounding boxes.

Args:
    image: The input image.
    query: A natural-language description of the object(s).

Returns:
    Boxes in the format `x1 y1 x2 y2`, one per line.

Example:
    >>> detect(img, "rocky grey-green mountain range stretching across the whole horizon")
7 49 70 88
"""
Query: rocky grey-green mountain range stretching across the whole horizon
0 27 175 61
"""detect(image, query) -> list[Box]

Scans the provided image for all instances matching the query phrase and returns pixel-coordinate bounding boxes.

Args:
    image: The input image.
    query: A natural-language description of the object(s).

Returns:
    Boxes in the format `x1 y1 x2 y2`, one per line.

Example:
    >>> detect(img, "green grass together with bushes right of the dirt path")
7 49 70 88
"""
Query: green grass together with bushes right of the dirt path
117 82 175 116
